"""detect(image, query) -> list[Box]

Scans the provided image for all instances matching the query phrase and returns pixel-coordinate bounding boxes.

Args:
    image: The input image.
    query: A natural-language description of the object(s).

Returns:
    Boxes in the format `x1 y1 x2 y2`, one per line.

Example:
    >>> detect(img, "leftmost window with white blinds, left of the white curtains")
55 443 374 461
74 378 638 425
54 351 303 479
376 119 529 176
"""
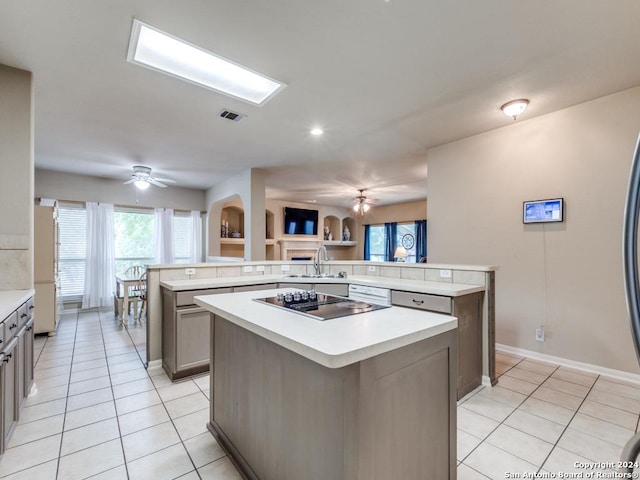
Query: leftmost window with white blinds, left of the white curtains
58 204 87 297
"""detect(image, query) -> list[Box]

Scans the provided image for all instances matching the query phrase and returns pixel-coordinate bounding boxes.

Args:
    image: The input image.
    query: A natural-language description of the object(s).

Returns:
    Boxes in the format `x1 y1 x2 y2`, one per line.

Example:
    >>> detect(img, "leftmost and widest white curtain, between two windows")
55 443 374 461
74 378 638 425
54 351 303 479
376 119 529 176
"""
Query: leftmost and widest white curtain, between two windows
82 202 115 308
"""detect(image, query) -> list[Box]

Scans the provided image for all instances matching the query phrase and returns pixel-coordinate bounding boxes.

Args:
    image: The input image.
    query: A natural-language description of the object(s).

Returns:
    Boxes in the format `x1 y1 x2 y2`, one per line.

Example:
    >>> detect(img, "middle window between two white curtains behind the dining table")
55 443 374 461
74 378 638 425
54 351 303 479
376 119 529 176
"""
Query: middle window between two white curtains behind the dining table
113 208 154 273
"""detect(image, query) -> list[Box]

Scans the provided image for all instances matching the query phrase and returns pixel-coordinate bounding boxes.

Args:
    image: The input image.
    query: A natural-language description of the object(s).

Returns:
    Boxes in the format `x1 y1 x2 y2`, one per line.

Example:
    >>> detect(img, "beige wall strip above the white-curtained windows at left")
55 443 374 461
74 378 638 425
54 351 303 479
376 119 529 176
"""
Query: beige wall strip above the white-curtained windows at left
35 169 205 211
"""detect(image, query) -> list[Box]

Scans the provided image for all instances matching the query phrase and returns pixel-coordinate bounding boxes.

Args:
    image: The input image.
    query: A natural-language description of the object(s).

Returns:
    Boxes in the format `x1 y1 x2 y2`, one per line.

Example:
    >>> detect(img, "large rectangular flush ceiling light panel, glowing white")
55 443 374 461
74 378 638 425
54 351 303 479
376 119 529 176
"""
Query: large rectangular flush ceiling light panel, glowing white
127 19 285 105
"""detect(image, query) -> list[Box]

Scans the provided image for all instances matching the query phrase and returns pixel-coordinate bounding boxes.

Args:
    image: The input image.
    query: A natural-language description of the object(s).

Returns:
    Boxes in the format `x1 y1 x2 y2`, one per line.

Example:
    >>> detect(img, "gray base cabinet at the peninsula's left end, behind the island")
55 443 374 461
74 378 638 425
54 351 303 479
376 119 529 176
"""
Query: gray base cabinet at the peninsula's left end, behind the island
162 288 232 380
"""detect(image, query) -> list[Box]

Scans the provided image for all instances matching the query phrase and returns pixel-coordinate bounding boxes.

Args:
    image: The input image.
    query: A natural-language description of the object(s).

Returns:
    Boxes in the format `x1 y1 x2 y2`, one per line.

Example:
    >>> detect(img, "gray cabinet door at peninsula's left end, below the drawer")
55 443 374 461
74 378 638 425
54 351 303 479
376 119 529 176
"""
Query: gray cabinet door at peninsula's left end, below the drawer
176 307 211 371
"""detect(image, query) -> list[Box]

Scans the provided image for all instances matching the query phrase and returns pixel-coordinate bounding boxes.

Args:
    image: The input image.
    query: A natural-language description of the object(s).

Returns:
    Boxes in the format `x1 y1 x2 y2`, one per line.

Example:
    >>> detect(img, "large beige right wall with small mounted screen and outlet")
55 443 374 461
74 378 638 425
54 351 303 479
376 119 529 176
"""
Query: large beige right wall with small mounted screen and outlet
428 87 640 373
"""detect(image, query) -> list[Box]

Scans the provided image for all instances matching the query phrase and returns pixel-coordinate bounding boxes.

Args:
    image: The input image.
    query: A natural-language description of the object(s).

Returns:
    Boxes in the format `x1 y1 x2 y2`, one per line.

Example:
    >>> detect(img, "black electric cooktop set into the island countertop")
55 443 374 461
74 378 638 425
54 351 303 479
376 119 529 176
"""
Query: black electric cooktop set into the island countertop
254 290 389 320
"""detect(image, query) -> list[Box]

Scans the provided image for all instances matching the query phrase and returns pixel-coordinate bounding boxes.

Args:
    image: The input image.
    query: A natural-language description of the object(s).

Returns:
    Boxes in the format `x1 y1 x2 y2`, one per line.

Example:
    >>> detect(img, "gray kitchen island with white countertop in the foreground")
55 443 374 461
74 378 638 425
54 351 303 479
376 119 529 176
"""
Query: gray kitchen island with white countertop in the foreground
195 290 457 480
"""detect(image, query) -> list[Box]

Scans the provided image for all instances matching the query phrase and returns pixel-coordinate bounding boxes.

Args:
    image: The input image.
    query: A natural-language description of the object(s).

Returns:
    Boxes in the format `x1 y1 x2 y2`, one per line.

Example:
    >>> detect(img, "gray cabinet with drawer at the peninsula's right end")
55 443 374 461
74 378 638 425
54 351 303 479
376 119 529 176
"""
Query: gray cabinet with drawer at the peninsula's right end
391 290 484 399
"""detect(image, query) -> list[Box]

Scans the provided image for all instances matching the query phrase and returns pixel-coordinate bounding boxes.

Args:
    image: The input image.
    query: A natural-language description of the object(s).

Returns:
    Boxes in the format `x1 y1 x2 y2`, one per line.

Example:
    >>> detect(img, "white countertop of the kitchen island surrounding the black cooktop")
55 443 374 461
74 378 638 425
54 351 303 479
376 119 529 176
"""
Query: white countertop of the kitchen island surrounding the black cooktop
195 289 458 368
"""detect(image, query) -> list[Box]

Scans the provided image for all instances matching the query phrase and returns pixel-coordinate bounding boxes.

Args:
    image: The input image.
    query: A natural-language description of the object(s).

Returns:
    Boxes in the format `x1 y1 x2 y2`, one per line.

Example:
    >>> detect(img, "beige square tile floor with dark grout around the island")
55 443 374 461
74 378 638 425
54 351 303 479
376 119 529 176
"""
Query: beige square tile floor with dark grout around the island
0 312 640 480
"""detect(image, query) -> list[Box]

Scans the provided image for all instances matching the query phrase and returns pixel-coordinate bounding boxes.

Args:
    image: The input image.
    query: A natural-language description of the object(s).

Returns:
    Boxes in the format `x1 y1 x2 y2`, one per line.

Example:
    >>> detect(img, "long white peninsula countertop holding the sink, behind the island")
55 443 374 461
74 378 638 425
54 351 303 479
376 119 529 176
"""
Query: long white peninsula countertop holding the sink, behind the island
160 275 485 297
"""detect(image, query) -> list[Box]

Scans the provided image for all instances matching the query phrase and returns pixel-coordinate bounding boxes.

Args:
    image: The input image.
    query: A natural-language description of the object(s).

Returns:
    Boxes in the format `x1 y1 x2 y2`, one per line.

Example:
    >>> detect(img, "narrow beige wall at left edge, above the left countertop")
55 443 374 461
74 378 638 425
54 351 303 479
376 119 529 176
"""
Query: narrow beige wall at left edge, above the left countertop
0 65 33 290
